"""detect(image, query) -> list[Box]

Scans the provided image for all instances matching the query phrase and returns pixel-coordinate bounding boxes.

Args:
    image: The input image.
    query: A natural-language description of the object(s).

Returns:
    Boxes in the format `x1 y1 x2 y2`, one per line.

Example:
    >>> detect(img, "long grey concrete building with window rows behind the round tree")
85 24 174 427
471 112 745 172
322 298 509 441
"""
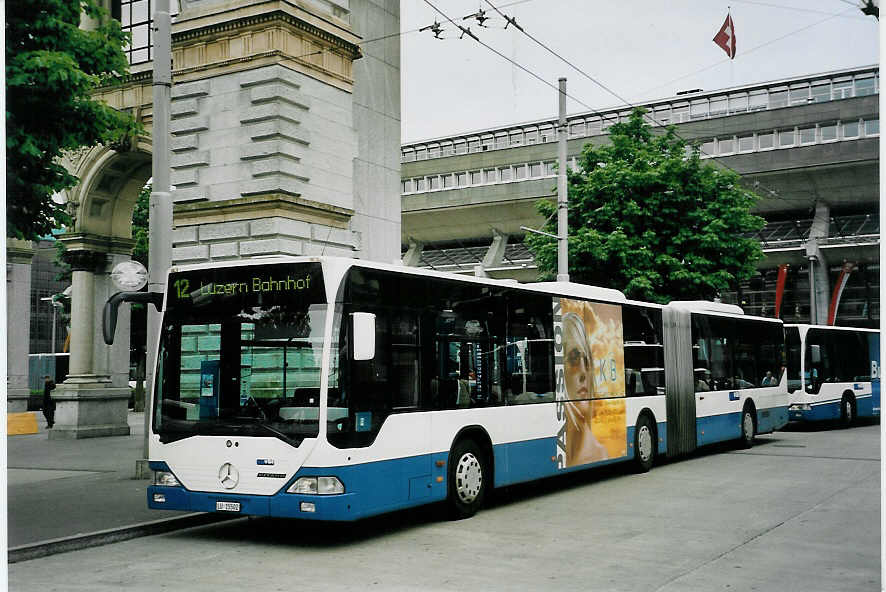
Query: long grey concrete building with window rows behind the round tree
401 66 880 327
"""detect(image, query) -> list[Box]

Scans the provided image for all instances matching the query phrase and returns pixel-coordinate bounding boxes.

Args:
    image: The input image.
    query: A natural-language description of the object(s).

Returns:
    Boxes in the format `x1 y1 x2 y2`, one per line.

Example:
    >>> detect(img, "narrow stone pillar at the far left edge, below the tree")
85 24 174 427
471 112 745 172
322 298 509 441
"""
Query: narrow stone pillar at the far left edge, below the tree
6 238 35 413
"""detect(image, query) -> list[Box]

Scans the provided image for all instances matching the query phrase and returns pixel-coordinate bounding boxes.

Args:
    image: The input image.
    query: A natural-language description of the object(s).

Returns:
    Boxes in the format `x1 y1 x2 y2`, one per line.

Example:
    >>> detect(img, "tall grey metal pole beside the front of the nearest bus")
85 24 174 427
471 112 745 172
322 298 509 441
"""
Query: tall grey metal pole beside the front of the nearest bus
136 0 172 478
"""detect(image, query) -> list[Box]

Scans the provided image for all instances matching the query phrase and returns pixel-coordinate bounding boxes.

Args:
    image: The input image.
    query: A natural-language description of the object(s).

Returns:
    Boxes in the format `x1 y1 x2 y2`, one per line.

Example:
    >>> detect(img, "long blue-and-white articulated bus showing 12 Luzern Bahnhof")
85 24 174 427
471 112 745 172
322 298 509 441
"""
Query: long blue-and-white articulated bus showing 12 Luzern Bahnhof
119 257 788 520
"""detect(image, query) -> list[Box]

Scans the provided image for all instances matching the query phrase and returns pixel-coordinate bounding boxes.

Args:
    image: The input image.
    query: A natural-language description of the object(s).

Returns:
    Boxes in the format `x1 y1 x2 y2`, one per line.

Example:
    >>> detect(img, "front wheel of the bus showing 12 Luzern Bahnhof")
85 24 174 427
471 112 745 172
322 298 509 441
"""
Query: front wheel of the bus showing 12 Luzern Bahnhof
447 439 488 520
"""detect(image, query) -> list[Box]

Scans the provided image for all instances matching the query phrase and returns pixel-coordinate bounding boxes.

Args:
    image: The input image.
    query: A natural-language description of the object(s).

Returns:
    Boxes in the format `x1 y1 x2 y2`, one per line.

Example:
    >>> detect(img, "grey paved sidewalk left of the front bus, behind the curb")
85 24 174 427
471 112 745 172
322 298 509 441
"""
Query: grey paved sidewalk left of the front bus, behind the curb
6 412 195 549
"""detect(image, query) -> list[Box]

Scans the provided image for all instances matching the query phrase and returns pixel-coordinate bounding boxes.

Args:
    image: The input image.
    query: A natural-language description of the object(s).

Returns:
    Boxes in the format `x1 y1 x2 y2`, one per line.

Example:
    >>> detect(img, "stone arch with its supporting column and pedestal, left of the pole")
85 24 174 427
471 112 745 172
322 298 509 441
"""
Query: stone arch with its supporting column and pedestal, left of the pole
50 138 151 439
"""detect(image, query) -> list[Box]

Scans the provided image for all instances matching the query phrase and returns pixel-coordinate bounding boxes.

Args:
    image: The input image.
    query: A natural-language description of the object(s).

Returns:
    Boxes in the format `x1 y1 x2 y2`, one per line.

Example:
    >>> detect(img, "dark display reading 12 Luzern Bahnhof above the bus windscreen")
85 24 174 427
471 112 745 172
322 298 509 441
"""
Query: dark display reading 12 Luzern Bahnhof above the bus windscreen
166 263 326 312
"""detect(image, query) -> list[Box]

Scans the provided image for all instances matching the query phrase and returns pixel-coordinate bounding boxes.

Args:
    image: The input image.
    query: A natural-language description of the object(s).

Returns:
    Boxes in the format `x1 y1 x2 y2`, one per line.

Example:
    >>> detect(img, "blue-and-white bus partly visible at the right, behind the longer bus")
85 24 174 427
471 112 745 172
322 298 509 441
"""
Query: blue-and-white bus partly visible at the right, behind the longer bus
785 325 880 427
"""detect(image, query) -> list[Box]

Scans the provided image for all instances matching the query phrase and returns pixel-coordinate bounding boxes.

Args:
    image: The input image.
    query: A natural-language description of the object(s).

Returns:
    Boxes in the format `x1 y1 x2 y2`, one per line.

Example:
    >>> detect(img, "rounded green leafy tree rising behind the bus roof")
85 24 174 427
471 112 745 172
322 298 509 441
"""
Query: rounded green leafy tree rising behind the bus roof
526 109 764 303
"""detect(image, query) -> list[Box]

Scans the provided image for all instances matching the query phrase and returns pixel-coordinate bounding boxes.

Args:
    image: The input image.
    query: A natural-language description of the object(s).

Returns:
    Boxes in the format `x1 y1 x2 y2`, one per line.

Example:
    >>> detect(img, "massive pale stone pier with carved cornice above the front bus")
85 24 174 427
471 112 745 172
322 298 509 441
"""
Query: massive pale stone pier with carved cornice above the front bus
170 0 382 263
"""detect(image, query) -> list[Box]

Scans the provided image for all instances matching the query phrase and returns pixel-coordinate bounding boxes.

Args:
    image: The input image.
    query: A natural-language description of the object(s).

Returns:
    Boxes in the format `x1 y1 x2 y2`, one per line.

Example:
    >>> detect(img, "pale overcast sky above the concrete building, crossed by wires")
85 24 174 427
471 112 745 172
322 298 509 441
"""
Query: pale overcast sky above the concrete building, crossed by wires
400 0 879 142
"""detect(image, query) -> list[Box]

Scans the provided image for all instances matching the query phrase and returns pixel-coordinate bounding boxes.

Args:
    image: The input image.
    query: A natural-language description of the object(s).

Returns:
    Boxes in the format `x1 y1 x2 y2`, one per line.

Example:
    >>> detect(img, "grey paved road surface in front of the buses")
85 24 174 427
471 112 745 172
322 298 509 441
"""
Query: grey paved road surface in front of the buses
8 423 881 592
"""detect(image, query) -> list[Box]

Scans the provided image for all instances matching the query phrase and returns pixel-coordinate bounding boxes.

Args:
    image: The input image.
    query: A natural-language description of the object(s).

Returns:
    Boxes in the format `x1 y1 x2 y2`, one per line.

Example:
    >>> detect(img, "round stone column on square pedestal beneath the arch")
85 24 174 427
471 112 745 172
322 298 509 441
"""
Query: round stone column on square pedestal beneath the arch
49 246 129 440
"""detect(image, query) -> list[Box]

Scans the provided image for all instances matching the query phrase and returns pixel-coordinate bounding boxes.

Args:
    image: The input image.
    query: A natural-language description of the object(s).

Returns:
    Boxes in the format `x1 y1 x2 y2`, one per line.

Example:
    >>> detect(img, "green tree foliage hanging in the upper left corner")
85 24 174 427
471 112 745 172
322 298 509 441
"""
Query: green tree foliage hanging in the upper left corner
6 0 138 239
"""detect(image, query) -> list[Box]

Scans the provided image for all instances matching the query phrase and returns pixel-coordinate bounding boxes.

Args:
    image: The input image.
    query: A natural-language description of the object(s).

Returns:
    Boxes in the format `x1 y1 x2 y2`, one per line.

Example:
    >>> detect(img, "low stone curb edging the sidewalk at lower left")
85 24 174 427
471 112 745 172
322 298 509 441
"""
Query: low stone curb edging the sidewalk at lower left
7 513 235 563
